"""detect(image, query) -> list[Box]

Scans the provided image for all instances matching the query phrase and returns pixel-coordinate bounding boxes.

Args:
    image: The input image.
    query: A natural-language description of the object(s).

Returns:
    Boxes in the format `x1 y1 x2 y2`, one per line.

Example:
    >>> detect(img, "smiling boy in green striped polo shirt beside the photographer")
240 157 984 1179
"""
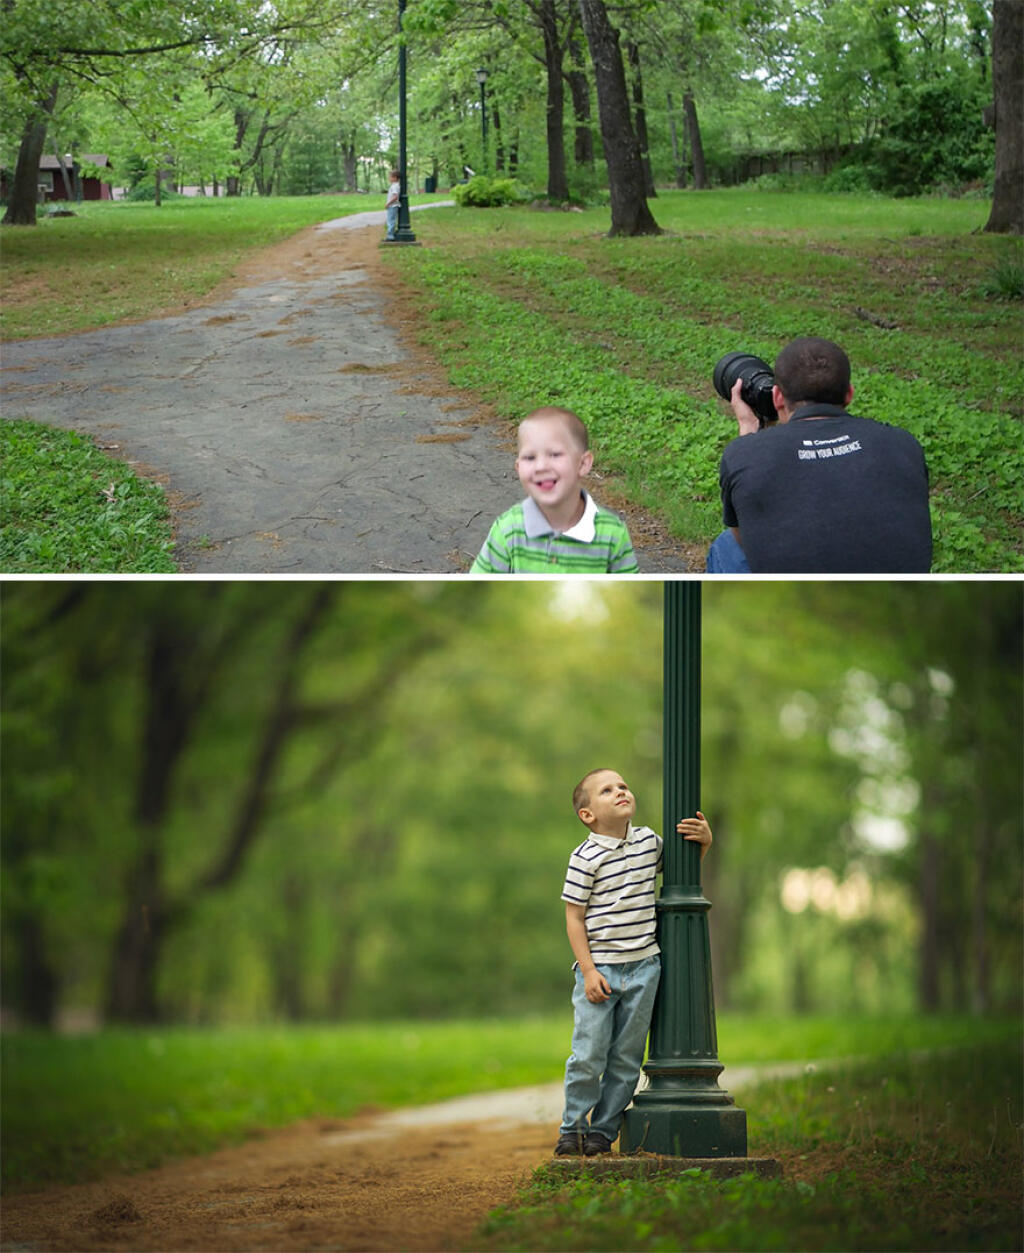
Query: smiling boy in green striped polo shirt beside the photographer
470 406 638 574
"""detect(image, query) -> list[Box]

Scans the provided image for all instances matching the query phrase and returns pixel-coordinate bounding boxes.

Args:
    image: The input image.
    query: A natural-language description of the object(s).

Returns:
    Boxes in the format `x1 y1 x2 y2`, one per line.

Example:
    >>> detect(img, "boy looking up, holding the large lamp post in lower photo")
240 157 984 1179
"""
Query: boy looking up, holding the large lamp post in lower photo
555 769 712 1158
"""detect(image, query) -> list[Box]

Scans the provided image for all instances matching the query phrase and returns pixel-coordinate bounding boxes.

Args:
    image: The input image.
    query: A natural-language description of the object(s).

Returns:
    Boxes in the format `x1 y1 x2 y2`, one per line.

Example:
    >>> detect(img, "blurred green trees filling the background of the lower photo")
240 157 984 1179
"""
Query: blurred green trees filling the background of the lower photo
3 580 1021 1022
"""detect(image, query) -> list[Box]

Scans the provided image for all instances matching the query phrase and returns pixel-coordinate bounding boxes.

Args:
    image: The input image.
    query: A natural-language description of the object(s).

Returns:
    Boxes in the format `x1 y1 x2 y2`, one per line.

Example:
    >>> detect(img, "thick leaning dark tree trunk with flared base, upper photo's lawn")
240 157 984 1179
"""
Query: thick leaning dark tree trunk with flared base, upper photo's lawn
579 0 662 236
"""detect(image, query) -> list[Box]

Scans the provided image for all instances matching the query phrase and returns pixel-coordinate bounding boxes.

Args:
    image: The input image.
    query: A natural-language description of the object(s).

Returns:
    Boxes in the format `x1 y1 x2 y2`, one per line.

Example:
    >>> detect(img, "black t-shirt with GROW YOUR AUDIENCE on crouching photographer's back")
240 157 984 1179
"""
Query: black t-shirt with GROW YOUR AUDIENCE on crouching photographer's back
719 405 931 574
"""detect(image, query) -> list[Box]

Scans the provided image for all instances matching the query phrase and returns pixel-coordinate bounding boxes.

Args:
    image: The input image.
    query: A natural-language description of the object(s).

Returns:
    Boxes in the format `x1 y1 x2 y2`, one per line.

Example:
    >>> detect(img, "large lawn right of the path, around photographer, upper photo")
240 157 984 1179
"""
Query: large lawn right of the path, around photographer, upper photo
386 192 1024 573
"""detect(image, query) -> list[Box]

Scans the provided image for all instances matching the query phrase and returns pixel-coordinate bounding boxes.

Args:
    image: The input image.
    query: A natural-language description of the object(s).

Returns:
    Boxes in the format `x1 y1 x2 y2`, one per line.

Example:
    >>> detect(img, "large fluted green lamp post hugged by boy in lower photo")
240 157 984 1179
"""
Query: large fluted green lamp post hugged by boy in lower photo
619 581 747 1158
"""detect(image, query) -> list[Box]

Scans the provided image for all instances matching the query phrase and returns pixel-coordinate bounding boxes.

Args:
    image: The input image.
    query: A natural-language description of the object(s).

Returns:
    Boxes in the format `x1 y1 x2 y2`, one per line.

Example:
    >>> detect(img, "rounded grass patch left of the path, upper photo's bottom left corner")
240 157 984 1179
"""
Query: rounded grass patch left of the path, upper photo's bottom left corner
0 421 177 574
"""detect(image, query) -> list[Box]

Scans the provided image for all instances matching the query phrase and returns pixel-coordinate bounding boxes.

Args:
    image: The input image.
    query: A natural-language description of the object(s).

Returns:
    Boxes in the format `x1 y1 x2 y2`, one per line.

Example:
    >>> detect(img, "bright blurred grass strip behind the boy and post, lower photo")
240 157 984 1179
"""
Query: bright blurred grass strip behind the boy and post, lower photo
3 1011 1011 1189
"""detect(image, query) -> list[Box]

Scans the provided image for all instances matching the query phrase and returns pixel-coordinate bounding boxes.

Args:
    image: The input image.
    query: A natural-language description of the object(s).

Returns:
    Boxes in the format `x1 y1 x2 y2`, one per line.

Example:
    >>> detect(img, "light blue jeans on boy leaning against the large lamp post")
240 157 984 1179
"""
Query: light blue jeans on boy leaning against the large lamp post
560 957 662 1140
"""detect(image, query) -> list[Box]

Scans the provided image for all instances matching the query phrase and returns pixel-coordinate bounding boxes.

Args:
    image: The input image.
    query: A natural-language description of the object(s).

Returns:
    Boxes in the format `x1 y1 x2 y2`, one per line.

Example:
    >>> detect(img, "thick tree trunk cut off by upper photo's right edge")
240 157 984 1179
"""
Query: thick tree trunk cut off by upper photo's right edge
985 0 1024 234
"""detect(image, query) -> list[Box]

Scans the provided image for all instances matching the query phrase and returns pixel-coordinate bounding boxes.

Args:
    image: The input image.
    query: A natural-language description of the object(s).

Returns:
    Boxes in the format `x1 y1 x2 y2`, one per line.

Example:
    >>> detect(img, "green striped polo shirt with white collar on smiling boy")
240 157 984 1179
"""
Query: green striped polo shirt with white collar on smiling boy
470 491 638 574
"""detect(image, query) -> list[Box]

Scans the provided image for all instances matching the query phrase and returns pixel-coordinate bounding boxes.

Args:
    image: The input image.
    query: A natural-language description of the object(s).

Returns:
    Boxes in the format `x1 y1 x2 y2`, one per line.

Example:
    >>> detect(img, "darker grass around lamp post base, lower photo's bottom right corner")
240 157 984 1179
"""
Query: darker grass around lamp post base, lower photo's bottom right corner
471 1040 1021 1253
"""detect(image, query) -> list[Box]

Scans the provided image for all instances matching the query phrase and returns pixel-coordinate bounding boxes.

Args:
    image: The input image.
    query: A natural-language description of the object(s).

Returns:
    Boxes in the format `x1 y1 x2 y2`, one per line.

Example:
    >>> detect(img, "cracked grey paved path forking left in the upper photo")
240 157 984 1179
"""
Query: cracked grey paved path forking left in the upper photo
3 212 688 576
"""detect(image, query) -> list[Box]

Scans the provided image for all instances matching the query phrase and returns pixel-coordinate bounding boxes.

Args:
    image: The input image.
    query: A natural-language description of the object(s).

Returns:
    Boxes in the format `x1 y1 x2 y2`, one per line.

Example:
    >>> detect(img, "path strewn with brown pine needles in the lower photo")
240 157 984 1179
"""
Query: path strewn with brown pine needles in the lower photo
1 1063 806 1253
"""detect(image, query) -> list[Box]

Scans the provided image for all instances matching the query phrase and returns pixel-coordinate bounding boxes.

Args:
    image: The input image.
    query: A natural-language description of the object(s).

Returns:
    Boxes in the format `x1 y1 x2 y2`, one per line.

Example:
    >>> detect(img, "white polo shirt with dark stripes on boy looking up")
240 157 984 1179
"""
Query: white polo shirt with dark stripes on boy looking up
562 824 662 965
